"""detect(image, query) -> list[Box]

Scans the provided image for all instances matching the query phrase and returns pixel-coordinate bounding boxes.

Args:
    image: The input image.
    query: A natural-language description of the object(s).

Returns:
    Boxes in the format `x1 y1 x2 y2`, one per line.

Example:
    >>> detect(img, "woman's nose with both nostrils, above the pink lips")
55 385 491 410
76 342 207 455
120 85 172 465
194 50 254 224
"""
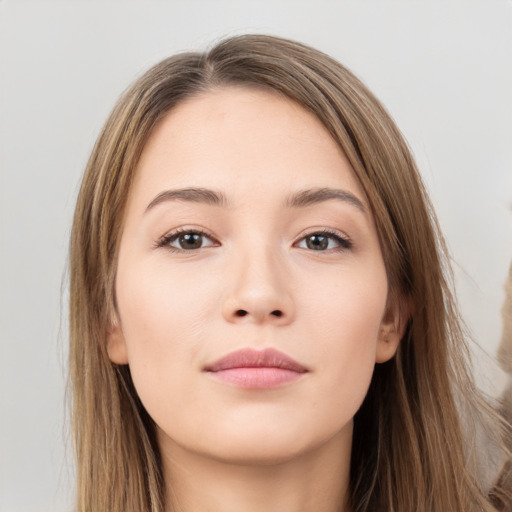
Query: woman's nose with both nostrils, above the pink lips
222 246 295 325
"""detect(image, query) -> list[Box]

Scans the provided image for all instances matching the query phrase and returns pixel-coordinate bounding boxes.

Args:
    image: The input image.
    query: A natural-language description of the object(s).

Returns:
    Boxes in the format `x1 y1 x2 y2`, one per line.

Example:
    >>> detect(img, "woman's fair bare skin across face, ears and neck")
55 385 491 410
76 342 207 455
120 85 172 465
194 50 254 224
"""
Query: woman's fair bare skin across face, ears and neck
108 87 401 512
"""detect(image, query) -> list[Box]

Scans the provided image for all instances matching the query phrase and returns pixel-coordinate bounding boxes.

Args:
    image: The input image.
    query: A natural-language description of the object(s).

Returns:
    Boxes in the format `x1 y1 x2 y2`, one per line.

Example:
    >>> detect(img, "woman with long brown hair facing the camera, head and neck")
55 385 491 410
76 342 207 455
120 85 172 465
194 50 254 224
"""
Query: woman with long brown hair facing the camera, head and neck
70 35 507 512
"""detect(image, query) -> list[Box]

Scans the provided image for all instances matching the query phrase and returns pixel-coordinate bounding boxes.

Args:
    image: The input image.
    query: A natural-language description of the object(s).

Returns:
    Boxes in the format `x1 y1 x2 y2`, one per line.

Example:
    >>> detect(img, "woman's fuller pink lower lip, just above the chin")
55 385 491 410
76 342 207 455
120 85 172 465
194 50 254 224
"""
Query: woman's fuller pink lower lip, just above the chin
209 367 304 389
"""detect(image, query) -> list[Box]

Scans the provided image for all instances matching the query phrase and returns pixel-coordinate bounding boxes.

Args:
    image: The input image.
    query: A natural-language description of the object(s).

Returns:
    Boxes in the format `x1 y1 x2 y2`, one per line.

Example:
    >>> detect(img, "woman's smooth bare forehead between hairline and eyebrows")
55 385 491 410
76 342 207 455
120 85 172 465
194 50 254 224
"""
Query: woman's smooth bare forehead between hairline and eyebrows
132 87 364 208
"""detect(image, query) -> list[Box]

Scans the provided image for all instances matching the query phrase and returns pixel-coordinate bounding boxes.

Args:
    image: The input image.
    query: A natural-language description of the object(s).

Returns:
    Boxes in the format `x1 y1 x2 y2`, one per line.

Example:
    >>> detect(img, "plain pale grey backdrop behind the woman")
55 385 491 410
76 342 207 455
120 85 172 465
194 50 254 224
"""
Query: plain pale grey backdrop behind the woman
0 0 512 512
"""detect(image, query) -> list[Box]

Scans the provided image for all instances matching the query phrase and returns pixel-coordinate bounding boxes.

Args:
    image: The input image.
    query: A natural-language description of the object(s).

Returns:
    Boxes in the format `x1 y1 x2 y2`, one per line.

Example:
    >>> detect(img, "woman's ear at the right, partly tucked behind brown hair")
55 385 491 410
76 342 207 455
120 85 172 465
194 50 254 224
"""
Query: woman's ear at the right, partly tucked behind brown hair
375 298 409 363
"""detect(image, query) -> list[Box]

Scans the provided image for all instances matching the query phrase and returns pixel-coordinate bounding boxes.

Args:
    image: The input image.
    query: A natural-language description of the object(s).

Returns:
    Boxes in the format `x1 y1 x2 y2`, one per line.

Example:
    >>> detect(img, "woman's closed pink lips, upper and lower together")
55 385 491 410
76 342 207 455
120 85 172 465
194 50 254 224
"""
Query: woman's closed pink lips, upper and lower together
204 348 308 389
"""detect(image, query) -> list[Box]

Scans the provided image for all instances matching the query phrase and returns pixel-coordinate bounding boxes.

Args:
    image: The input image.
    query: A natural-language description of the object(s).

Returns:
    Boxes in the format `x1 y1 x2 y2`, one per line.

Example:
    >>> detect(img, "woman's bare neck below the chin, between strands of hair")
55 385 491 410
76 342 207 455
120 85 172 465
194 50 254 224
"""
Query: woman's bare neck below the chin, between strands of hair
160 424 352 512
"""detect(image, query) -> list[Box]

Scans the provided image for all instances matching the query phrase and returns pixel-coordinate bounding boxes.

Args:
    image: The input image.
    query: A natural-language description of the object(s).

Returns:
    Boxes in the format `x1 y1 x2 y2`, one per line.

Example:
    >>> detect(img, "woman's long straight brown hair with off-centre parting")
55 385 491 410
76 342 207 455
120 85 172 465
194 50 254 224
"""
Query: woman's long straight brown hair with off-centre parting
70 35 506 512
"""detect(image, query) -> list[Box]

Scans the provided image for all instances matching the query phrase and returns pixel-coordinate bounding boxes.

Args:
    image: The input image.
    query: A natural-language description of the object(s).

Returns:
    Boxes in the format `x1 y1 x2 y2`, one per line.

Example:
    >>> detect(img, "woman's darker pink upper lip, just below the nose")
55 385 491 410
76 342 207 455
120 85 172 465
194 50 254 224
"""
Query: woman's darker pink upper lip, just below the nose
205 348 308 373
